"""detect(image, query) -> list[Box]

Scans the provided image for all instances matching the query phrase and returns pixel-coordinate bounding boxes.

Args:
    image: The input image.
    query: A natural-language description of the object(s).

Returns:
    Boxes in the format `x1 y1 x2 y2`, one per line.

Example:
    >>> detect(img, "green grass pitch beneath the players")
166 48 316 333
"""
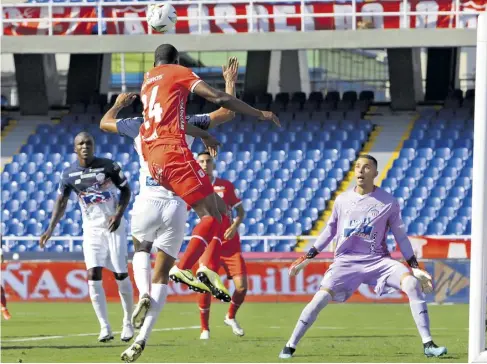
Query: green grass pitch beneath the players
1 303 468 363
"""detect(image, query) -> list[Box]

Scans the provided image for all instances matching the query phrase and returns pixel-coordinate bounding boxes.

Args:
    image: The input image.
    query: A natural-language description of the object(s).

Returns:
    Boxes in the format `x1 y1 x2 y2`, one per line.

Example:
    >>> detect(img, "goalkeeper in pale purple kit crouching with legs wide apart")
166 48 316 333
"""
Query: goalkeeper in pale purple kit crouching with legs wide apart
279 155 447 359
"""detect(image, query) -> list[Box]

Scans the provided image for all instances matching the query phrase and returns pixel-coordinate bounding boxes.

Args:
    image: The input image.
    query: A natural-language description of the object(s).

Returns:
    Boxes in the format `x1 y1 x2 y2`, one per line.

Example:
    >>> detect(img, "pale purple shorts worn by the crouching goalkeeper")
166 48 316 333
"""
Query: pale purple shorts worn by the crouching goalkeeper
321 256 410 302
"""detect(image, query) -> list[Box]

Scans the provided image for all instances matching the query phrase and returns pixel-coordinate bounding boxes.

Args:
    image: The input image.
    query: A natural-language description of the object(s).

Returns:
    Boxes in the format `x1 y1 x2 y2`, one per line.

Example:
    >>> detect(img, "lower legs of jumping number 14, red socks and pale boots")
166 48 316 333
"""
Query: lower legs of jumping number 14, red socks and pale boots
170 193 231 302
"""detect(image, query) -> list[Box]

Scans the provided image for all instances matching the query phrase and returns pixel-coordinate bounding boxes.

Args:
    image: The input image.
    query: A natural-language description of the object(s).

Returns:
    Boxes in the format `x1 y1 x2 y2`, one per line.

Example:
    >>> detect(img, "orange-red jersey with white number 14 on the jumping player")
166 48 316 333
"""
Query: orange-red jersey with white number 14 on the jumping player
140 64 201 156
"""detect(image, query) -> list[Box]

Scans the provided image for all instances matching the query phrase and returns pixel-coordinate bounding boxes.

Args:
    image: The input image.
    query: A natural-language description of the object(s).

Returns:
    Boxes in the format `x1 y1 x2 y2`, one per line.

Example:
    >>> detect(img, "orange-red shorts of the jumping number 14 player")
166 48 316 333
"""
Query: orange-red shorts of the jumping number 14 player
147 145 214 206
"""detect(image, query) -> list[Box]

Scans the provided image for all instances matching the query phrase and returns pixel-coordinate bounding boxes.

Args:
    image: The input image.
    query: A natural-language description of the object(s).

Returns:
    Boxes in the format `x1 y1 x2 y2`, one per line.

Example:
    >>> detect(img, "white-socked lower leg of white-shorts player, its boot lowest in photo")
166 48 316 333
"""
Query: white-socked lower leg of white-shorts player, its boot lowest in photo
120 250 175 363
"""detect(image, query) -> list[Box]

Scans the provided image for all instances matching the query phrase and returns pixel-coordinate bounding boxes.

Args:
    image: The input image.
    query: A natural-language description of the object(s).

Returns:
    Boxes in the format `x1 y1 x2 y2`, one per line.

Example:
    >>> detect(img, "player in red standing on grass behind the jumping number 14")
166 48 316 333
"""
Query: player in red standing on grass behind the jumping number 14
197 152 247 340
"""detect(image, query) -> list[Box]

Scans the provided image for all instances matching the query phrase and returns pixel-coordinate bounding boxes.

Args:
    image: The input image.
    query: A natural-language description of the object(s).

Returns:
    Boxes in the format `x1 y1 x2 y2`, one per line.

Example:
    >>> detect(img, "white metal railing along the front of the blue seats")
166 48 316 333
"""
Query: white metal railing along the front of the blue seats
2 235 326 252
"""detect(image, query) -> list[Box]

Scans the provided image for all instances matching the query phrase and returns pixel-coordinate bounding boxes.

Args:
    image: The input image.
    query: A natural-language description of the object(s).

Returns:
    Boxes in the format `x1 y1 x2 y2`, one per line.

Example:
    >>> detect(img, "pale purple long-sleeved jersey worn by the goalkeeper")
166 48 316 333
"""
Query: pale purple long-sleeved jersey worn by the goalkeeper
314 187 414 260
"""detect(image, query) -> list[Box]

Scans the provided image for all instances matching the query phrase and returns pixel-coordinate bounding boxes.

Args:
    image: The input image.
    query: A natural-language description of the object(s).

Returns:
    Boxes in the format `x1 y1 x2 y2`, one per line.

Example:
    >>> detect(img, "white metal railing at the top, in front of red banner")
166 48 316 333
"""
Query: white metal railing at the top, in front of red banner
0 0 486 36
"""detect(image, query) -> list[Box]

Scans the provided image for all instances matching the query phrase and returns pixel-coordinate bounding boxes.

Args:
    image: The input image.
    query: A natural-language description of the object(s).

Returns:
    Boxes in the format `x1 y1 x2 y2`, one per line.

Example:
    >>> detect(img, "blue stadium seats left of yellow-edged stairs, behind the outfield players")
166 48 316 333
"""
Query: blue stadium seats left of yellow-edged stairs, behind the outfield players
2 92 374 255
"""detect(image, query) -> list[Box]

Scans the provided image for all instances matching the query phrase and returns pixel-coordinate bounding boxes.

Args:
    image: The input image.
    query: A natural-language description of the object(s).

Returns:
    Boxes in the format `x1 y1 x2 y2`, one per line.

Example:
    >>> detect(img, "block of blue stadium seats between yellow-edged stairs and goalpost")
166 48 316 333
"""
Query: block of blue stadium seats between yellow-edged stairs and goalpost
382 90 474 235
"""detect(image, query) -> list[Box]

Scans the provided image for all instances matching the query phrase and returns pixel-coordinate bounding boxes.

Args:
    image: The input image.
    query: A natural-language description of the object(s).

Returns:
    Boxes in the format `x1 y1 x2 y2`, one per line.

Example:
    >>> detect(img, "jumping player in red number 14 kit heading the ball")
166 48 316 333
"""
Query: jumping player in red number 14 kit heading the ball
140 44 279 301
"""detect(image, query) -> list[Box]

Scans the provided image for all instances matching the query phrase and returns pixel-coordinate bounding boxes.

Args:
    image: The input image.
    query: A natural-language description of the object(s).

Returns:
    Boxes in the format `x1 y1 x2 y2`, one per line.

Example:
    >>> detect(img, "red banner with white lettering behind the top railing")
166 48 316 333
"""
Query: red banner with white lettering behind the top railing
3 0 487 35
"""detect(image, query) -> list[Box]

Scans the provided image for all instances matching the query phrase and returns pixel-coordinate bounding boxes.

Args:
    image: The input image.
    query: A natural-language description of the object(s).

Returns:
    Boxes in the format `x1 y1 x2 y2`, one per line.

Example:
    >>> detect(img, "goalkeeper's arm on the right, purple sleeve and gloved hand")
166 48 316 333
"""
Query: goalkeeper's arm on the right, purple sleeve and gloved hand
388 201 433 293
